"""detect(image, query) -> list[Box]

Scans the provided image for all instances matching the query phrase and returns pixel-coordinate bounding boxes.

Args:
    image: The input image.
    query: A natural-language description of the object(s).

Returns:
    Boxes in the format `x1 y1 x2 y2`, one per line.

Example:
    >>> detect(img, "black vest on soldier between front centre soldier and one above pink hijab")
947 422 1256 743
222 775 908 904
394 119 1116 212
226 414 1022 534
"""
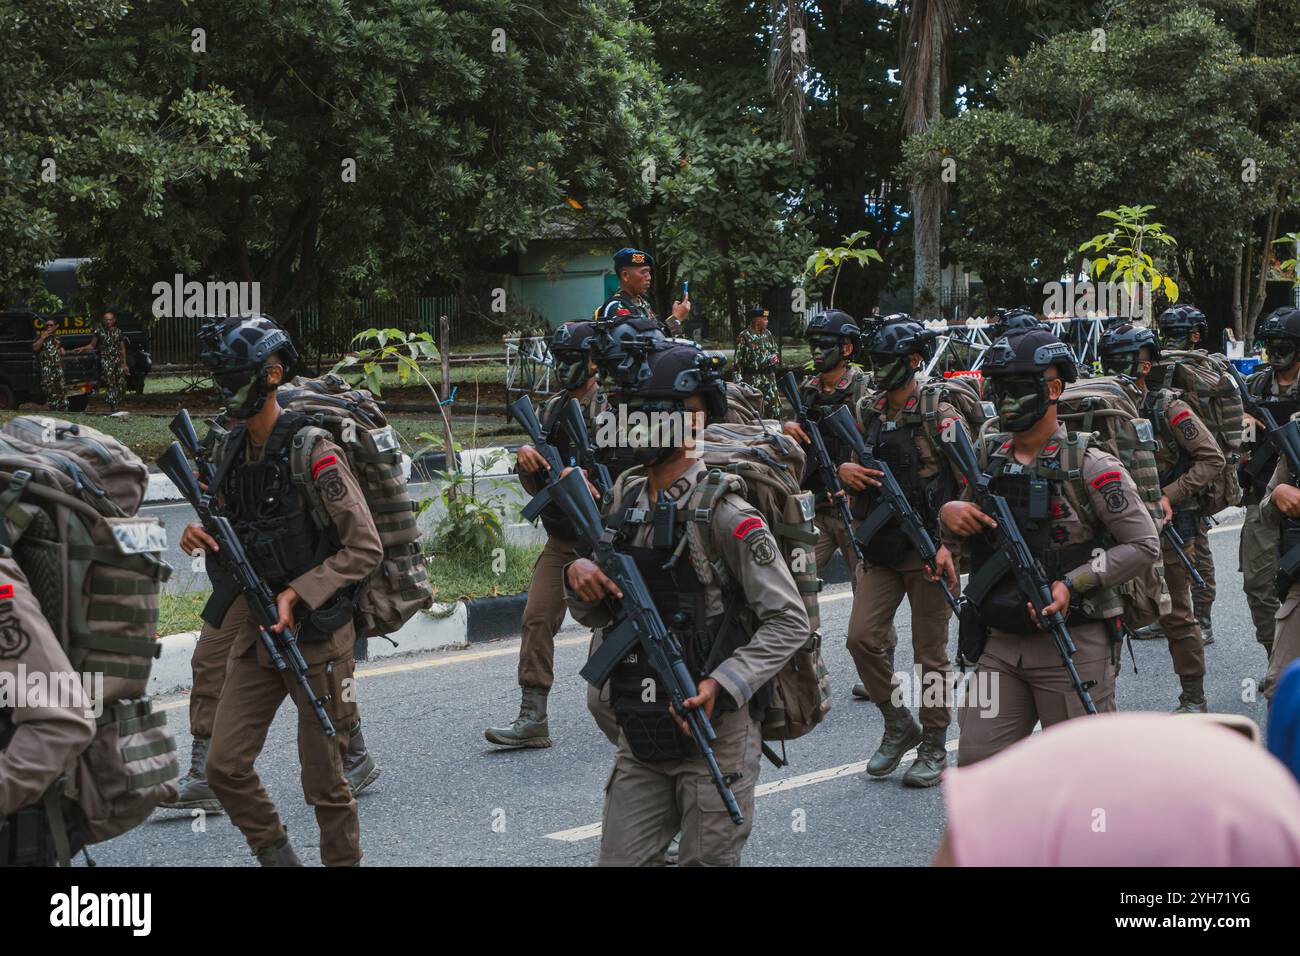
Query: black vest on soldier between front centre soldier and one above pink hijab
859 390 957 567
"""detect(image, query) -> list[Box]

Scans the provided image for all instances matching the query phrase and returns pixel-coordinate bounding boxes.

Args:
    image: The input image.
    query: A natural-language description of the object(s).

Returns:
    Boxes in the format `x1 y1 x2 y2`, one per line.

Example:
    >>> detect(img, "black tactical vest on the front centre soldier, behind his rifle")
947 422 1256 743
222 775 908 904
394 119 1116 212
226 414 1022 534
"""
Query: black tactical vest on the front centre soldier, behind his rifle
607 488 735 760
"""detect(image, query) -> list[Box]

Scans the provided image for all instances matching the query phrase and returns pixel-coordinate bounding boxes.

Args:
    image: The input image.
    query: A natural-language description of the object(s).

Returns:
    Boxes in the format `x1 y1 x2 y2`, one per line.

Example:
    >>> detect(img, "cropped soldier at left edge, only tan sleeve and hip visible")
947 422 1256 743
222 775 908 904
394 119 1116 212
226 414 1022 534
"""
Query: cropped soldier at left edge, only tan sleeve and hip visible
0 554 95 868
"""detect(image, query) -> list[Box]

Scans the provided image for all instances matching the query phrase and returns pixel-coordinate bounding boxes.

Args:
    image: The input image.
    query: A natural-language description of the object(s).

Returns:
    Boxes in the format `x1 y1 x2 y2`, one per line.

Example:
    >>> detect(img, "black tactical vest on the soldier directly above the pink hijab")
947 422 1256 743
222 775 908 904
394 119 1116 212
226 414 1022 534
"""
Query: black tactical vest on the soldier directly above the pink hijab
966 433 1123 635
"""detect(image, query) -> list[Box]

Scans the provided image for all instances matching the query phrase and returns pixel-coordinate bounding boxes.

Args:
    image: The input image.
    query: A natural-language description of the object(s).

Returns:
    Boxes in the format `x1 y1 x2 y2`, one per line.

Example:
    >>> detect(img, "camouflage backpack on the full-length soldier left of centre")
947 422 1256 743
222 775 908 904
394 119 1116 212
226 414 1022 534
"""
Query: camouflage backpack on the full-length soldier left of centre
276 373 433 639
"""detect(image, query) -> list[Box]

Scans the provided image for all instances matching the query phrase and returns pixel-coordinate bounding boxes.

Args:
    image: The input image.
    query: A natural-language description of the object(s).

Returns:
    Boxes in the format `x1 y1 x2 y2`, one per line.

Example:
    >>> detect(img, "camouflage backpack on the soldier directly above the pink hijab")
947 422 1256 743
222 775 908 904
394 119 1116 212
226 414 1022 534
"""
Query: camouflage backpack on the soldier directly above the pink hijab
1057 377 1170 627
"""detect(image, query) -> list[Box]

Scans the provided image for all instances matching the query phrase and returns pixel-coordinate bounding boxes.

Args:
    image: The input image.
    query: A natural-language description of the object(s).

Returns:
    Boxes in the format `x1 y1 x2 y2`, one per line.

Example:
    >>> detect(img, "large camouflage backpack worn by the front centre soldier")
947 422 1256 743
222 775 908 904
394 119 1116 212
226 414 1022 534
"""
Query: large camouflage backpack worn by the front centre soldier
623 423 831 740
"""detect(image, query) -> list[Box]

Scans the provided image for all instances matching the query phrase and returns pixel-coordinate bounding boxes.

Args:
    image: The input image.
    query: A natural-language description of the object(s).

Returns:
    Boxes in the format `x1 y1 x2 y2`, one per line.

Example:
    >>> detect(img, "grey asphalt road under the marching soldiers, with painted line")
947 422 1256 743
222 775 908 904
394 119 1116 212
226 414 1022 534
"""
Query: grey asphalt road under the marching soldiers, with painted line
92 515 1265 866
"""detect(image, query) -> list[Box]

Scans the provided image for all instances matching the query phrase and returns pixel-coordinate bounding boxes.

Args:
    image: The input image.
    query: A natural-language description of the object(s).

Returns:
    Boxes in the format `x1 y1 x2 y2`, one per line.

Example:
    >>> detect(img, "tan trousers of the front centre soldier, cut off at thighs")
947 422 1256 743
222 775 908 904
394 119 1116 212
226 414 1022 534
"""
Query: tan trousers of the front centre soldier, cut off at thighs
601 706 763 866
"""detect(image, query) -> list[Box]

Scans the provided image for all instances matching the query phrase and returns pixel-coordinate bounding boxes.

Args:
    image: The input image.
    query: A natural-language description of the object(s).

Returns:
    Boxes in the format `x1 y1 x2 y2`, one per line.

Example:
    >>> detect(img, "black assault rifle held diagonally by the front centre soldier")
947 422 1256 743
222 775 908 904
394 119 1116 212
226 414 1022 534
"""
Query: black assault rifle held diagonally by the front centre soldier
547 468 745 826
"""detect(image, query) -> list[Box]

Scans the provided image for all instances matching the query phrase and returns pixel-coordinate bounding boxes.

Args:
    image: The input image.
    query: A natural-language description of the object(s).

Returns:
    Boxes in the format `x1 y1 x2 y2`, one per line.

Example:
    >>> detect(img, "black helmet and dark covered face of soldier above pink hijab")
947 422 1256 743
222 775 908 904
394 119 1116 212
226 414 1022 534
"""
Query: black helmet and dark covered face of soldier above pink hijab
980 329 1079 432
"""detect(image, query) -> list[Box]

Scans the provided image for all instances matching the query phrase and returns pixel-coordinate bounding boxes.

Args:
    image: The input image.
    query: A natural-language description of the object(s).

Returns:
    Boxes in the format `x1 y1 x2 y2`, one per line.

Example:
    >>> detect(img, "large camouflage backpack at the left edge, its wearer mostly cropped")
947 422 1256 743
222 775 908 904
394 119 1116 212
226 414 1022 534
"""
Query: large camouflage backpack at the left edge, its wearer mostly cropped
0 416 179 865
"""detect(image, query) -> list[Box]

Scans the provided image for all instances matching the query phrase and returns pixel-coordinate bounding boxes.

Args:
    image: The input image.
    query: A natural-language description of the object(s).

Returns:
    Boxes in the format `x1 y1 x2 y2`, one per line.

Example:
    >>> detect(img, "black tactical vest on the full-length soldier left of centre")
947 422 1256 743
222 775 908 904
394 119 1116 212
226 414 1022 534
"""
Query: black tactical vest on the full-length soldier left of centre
203 411 340 641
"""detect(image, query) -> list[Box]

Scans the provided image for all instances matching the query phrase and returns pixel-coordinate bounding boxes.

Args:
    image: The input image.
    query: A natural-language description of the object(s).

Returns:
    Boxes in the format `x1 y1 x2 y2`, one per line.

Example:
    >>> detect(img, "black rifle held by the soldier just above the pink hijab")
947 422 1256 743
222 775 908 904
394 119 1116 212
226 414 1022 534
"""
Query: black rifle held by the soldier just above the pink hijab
939 423 1097 714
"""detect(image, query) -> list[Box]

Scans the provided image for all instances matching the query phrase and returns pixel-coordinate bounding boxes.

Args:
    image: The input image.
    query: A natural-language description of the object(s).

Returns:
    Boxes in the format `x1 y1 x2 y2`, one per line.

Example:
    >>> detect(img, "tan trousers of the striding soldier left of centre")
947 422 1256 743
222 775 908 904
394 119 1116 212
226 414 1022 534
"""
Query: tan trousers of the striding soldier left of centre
208 601 361 866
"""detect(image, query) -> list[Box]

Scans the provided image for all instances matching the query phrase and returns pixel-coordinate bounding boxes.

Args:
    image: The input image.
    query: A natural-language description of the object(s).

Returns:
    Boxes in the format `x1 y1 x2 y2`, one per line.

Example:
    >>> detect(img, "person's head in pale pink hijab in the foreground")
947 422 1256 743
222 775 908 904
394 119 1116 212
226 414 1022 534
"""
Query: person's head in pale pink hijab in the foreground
935 713 1300 866
